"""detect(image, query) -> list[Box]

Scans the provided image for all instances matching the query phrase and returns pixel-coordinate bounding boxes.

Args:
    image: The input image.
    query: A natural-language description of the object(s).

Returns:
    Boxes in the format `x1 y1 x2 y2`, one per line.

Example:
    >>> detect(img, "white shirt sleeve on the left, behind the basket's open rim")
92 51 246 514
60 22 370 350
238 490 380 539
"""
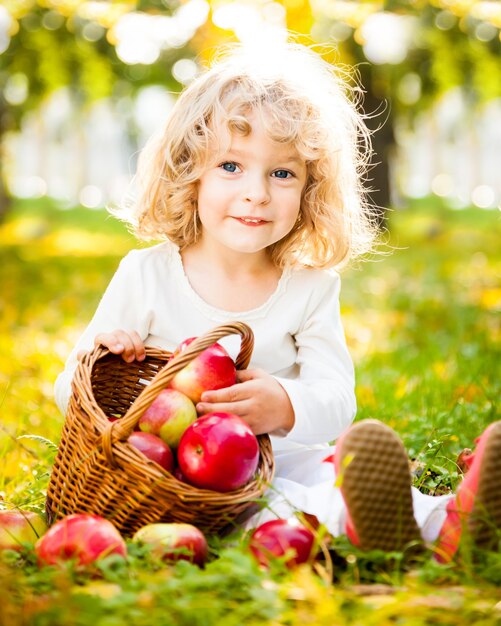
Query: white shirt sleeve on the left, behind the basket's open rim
54 251 149 414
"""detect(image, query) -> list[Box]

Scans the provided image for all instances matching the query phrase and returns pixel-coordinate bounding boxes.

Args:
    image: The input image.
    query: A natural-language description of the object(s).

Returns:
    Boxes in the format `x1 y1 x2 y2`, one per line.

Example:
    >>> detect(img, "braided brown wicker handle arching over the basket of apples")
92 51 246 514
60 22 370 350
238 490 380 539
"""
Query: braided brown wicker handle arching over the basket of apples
102 322 254 465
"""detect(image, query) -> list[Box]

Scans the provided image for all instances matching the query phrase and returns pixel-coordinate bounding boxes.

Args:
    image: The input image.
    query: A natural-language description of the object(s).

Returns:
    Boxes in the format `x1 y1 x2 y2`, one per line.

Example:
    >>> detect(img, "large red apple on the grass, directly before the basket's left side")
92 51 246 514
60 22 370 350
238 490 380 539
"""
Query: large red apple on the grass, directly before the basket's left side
35 513 127 566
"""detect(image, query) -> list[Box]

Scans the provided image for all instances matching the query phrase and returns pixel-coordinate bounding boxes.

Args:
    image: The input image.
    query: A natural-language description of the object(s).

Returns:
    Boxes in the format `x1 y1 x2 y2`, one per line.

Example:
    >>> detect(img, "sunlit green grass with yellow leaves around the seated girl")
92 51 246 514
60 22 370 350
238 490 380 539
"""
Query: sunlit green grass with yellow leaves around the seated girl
0 194 501 626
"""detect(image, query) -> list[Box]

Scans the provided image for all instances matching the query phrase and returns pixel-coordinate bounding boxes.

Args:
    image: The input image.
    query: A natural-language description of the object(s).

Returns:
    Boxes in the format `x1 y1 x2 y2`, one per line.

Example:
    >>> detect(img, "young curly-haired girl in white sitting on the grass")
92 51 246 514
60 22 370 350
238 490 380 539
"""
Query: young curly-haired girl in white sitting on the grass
55 44 500 560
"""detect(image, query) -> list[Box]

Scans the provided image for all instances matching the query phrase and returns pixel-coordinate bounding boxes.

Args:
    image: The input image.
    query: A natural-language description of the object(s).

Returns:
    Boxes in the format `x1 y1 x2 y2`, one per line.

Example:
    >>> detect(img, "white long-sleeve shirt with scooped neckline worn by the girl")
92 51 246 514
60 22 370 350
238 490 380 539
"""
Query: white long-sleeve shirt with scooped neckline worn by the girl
55 242 356 451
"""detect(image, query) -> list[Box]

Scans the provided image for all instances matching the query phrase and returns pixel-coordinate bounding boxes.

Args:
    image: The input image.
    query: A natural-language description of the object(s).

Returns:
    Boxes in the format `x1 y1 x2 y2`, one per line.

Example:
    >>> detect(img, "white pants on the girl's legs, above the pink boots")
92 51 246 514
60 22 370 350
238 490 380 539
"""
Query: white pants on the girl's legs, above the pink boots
244 447 454 542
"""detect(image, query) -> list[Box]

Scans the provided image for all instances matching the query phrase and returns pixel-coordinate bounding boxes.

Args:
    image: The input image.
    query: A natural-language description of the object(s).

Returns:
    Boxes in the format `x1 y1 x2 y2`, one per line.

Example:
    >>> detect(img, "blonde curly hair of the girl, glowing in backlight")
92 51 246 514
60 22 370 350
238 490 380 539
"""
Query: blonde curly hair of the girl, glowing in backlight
121 42 377 268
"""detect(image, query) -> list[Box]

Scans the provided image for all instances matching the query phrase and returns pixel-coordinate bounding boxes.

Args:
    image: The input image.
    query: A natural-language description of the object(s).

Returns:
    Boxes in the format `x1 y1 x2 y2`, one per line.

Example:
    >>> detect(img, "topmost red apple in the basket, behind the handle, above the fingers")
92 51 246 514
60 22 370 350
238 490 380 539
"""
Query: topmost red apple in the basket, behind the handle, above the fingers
169 337 237 404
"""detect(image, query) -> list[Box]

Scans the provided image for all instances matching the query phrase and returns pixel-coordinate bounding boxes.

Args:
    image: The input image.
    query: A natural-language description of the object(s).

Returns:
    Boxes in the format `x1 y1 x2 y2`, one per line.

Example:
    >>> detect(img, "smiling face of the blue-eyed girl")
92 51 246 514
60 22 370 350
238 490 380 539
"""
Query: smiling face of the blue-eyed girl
198 110 307 254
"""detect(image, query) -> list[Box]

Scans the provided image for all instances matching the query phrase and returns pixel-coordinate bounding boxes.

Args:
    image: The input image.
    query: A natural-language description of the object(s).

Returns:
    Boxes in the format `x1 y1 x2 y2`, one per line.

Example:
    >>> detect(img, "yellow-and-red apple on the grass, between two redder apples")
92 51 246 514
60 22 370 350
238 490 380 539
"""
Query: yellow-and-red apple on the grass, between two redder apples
132 523 208 566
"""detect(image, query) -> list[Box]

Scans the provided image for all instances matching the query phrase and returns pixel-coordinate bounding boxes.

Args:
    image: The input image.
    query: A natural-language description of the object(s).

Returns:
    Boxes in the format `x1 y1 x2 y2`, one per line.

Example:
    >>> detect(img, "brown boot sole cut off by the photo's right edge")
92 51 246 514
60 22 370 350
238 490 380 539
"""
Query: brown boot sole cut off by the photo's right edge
468 422 501 548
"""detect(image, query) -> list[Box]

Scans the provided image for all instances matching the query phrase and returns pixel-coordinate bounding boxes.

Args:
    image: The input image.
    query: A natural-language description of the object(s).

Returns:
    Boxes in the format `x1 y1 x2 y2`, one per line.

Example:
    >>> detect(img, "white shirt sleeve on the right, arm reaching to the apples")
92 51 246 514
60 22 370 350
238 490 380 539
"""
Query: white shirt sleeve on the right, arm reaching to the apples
276 274 356 445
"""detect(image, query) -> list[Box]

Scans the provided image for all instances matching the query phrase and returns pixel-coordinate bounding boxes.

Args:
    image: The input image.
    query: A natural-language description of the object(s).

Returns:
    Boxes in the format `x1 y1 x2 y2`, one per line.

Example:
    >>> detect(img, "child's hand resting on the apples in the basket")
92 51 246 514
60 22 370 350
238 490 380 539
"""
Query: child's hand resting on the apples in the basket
197 369 294 435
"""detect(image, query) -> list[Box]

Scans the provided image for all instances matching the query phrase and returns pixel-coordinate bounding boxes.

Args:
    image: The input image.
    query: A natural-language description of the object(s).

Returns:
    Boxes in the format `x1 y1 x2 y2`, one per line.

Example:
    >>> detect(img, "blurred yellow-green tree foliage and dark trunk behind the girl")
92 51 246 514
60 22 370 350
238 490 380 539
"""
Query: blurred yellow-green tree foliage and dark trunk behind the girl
0 0 501 215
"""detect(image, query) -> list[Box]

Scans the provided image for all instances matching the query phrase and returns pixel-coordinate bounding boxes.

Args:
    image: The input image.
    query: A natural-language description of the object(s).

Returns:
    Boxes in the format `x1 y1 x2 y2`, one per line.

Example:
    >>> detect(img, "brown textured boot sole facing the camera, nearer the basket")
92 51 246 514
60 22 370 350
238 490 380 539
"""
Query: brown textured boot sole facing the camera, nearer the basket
339 420 422 551
